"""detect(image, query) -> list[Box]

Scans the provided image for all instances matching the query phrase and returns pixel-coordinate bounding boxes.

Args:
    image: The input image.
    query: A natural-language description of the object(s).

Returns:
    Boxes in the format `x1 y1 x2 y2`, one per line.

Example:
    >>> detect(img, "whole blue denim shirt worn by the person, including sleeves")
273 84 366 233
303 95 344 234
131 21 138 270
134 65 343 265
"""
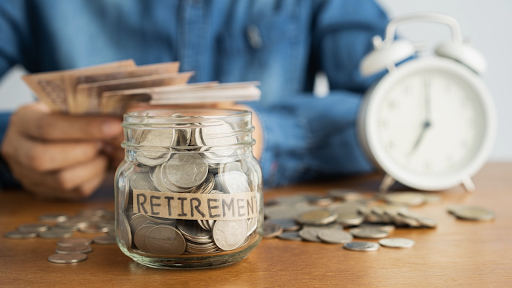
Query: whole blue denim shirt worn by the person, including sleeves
0 0 388 186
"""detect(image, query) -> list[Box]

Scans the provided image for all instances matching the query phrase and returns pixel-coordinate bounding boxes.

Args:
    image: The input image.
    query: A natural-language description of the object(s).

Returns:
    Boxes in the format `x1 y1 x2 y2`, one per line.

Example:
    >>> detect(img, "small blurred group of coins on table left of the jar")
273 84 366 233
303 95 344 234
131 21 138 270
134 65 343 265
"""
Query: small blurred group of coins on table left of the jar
4 209 116 264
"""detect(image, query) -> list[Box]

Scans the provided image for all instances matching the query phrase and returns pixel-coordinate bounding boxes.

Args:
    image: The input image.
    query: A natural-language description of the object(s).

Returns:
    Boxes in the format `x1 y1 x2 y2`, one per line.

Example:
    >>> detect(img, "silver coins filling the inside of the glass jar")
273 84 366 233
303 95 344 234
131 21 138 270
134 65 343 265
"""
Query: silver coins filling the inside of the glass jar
119 114 258 255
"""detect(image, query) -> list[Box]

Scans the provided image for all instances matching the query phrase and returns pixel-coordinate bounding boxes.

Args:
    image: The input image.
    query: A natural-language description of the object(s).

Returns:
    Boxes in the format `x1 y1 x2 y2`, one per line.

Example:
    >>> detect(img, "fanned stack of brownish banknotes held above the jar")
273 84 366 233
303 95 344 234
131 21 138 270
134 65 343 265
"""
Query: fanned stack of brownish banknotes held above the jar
23 60 261 114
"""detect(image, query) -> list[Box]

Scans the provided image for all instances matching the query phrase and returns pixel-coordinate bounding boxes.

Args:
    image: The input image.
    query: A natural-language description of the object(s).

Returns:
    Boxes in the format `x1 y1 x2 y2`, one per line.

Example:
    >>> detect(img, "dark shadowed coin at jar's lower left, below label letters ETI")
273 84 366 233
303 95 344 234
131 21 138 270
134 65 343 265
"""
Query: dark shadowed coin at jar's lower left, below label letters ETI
146 225 186 255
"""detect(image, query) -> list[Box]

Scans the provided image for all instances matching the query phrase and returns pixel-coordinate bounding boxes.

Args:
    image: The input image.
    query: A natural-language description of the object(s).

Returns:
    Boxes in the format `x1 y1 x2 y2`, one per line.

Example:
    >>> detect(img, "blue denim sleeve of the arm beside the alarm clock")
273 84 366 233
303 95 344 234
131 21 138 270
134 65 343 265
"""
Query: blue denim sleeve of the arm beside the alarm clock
248 0 388 187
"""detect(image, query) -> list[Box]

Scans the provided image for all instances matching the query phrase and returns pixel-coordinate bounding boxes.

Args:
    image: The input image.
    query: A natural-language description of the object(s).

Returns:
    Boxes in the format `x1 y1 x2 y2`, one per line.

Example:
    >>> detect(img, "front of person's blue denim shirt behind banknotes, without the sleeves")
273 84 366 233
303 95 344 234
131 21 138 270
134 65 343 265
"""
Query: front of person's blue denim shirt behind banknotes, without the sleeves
25 0 320 103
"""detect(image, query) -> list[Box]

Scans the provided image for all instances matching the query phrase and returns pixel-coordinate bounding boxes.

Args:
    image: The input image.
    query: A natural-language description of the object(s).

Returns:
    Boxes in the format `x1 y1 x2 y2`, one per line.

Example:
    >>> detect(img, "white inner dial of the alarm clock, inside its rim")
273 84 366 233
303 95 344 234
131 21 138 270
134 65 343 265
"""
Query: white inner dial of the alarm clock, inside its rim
376 70 486 175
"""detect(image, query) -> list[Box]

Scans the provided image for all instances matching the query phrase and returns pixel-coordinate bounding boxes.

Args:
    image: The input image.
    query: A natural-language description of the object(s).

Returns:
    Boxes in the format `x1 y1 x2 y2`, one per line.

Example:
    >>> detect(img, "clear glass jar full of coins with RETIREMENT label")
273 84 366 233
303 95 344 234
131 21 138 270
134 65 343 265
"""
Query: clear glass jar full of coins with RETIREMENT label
115 109 263 269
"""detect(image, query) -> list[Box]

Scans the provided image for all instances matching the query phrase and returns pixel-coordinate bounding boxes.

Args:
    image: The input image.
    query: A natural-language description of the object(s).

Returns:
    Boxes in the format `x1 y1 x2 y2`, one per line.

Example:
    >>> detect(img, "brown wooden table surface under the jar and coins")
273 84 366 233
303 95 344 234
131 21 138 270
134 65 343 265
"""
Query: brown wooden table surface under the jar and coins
0 163 512 287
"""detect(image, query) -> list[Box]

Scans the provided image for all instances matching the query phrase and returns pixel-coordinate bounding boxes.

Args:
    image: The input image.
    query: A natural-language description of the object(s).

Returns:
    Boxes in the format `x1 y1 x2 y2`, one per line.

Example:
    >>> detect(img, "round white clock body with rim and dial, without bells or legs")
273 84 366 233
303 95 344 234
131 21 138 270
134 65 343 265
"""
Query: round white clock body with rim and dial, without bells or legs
364 59 495 190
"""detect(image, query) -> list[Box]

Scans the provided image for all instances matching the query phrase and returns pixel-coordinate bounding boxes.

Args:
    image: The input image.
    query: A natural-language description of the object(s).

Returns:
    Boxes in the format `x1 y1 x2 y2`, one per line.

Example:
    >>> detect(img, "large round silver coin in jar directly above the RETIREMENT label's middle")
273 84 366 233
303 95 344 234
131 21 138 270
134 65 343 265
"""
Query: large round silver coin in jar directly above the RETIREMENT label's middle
164 154 208 188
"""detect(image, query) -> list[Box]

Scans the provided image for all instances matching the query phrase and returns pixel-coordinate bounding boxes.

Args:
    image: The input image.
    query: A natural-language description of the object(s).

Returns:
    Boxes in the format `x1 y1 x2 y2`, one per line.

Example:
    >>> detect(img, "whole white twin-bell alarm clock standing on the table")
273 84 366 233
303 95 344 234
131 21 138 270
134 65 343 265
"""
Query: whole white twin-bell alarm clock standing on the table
357 14 497 192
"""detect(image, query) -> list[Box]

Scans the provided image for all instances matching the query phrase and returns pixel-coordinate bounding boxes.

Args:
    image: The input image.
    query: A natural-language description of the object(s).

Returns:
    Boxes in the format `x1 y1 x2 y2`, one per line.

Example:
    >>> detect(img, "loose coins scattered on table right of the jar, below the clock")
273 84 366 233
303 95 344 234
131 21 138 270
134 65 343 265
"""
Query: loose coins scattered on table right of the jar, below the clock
263 189 494 251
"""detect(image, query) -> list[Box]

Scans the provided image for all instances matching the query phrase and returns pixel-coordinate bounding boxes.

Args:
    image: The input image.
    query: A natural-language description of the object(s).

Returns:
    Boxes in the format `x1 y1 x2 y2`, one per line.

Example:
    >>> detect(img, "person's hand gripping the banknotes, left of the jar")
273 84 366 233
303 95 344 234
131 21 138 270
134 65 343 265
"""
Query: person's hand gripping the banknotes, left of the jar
0 103 122 199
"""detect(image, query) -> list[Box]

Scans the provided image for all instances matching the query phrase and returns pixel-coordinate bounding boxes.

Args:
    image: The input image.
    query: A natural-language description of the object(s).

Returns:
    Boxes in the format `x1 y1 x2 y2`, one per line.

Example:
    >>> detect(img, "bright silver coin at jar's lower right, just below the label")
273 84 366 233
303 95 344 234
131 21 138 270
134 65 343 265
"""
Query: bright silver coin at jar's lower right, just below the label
213 219 248 251
